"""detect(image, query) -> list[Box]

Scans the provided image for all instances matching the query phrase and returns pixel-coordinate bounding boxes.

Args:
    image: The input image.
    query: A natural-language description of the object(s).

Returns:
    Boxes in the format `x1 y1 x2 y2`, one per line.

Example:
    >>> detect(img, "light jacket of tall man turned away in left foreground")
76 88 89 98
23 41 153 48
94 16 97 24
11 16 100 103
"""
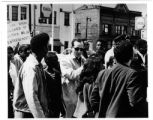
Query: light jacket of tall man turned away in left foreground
13 54 48 118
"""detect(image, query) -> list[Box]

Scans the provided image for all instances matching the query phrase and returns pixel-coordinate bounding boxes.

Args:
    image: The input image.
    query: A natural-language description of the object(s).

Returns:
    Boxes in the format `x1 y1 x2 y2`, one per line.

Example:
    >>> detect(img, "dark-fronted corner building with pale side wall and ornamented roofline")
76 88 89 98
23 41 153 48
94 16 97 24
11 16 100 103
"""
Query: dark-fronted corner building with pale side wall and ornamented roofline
75 4 141 49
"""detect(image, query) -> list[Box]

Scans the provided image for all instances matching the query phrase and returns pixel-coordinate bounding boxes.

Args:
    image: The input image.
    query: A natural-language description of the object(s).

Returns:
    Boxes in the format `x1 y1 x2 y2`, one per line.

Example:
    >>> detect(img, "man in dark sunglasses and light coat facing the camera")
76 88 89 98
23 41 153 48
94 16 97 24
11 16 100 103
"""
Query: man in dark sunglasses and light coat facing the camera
60 39 85 117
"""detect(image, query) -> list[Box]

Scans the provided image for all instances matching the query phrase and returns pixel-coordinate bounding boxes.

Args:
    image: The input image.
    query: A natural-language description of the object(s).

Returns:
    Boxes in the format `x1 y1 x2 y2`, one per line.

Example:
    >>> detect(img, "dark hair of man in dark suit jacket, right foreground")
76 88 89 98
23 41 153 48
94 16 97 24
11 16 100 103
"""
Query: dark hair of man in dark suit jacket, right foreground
114 41 133 64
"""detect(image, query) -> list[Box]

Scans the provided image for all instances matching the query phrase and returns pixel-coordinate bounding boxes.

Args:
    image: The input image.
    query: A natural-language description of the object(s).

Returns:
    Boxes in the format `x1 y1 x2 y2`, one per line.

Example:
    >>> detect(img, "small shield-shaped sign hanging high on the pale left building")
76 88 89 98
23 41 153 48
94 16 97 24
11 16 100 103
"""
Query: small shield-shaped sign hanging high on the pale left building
42 4 52 17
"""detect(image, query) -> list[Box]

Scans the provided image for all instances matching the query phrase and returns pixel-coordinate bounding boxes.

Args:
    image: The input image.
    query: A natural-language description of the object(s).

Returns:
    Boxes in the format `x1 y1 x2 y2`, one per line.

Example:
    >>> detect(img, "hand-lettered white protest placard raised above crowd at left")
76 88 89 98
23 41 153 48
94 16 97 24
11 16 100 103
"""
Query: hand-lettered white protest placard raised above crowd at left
7 20 31 47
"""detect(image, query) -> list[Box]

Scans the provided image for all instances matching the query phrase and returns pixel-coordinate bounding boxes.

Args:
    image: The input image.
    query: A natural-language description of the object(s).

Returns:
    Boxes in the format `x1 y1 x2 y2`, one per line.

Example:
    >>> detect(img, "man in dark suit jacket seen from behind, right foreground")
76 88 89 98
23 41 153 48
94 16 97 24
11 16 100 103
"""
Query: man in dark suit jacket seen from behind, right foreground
91 41 147 118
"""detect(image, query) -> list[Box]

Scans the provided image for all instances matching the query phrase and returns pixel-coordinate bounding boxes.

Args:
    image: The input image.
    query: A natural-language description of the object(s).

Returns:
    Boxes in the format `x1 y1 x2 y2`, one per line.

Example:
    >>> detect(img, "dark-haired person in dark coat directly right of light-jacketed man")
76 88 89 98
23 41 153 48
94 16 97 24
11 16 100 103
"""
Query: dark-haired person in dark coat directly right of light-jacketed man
44 52 66 118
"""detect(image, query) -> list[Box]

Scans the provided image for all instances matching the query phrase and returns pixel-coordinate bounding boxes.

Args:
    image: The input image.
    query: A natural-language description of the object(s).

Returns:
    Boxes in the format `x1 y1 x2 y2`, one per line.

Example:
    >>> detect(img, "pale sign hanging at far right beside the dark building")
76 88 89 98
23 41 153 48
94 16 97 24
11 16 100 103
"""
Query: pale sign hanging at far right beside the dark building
135 17 145 30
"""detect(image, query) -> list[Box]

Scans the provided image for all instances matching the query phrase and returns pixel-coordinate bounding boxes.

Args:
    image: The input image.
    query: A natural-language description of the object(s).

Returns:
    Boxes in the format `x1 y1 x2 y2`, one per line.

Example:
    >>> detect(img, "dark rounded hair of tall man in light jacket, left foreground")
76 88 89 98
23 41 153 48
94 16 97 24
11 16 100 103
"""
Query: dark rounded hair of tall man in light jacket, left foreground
30 33 49 53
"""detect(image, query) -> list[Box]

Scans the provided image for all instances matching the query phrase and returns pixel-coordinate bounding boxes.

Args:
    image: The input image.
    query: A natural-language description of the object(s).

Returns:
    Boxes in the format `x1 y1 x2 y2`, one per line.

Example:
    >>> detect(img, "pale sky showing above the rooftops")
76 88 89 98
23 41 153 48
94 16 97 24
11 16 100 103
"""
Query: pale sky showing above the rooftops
75 4 147 16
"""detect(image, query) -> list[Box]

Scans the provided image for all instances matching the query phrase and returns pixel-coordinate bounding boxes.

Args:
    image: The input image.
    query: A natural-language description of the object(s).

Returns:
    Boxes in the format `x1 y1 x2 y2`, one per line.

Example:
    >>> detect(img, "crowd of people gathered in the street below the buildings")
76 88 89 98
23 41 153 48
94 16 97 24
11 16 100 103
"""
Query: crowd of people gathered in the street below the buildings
7 33 148 118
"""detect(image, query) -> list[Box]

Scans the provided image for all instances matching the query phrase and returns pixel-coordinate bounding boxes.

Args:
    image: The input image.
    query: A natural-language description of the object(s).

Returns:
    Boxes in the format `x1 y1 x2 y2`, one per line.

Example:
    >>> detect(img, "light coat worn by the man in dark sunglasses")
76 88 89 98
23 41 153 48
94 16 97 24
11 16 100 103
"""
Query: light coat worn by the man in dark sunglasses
60 54 85 117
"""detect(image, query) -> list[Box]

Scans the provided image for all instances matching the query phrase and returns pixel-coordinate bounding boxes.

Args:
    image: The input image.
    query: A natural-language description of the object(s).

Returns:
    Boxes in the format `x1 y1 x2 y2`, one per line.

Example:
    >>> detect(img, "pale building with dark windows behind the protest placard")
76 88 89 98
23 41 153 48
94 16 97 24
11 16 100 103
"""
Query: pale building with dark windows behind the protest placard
7 4 74 53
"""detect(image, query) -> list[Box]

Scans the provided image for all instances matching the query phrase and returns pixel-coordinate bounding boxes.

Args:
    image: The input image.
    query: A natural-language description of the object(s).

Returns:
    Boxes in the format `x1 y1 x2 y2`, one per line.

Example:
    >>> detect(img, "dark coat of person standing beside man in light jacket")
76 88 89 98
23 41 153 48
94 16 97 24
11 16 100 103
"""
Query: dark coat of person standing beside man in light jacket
45 71 65 118
